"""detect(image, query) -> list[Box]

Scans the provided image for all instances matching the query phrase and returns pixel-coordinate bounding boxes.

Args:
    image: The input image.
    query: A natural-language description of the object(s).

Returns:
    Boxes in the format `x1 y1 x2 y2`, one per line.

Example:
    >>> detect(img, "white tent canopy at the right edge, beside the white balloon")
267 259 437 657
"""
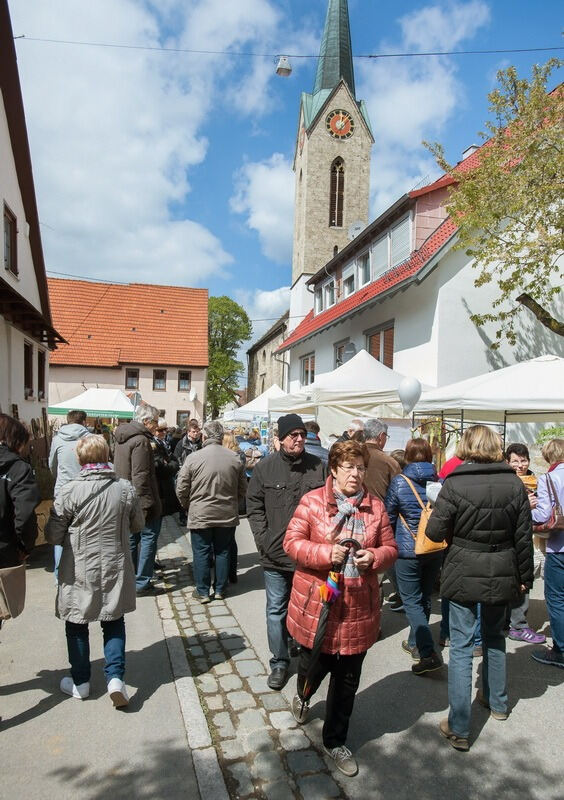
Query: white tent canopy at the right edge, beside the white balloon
415 355 564 422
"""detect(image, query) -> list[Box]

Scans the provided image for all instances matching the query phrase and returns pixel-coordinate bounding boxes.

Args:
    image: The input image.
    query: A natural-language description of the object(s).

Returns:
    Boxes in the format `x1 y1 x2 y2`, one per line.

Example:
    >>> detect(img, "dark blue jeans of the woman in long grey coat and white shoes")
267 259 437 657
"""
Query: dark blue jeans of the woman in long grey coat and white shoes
65 617 125 686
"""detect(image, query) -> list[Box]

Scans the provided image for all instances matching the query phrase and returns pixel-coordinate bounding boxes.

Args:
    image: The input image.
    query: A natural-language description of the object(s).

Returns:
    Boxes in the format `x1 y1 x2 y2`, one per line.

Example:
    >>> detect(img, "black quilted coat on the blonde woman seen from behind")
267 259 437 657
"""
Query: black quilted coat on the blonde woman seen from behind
426 461 533 605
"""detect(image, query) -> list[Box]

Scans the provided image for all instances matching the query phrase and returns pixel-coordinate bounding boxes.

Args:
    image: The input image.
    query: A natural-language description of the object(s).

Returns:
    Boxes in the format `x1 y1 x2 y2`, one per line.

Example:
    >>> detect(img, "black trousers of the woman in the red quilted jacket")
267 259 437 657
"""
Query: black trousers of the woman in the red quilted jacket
298 647 366 750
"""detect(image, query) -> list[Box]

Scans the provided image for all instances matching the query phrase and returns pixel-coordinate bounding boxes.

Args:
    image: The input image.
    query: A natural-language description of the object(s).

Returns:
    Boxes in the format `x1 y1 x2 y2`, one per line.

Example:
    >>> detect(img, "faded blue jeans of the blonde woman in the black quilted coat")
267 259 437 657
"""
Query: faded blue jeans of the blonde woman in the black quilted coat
448 600 507 739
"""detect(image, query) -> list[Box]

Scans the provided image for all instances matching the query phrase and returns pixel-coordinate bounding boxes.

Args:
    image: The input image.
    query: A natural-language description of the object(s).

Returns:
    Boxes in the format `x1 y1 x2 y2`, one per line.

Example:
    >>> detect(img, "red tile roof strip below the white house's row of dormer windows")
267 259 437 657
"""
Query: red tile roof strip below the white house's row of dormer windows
277 217 457 352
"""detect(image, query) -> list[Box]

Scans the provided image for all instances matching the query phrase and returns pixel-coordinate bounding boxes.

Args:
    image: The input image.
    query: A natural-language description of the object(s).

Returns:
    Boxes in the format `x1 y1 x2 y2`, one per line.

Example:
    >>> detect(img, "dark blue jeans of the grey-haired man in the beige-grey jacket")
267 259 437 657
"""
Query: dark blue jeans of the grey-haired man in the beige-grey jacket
190 526 235 597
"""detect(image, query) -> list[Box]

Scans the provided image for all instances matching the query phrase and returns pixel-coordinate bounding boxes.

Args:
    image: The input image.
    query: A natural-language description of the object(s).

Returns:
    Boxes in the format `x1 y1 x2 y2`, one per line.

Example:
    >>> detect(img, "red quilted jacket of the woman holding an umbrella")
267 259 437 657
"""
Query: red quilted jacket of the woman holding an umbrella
284 476 398 655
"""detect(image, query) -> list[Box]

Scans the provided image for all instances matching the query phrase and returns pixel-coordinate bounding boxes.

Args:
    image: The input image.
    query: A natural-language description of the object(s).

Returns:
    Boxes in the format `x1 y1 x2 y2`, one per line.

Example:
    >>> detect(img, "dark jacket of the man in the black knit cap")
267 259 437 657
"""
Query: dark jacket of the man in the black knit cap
247 449 326 572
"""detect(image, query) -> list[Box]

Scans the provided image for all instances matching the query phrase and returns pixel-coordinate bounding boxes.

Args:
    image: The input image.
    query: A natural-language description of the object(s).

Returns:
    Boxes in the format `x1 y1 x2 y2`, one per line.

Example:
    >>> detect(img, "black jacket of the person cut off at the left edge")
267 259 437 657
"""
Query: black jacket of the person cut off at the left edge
0 444 41 568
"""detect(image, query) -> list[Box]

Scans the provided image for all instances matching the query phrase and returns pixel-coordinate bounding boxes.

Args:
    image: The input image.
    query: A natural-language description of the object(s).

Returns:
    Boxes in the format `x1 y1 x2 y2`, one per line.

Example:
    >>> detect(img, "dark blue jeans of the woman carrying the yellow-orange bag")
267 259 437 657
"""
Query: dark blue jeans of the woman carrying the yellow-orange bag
395 553 443 658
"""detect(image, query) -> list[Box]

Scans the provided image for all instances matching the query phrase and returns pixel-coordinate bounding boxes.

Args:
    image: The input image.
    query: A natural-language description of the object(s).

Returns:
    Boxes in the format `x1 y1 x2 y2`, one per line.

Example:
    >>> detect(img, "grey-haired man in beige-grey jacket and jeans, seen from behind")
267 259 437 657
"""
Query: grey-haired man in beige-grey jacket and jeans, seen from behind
176 420 247 603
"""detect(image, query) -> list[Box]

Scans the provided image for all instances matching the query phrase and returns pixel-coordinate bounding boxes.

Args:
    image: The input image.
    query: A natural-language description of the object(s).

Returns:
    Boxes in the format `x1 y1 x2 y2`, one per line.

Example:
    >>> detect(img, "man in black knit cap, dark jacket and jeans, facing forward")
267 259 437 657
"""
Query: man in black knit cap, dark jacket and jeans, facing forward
247 414 325 690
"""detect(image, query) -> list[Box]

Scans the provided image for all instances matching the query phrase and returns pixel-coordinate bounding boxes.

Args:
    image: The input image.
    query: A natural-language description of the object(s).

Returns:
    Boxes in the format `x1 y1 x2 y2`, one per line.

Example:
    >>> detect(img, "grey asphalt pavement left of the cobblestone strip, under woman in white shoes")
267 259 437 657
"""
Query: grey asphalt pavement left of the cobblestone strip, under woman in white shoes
0 532 199 800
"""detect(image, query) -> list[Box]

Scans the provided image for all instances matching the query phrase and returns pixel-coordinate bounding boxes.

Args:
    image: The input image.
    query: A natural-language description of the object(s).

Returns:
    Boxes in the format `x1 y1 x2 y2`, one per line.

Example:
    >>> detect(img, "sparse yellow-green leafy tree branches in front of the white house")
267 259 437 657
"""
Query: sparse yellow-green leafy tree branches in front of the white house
424 58 564 349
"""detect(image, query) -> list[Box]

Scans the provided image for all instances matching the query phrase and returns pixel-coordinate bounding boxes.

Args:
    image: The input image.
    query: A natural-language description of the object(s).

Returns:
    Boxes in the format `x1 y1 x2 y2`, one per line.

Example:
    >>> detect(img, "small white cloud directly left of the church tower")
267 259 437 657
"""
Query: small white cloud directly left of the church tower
231 153 294 265
